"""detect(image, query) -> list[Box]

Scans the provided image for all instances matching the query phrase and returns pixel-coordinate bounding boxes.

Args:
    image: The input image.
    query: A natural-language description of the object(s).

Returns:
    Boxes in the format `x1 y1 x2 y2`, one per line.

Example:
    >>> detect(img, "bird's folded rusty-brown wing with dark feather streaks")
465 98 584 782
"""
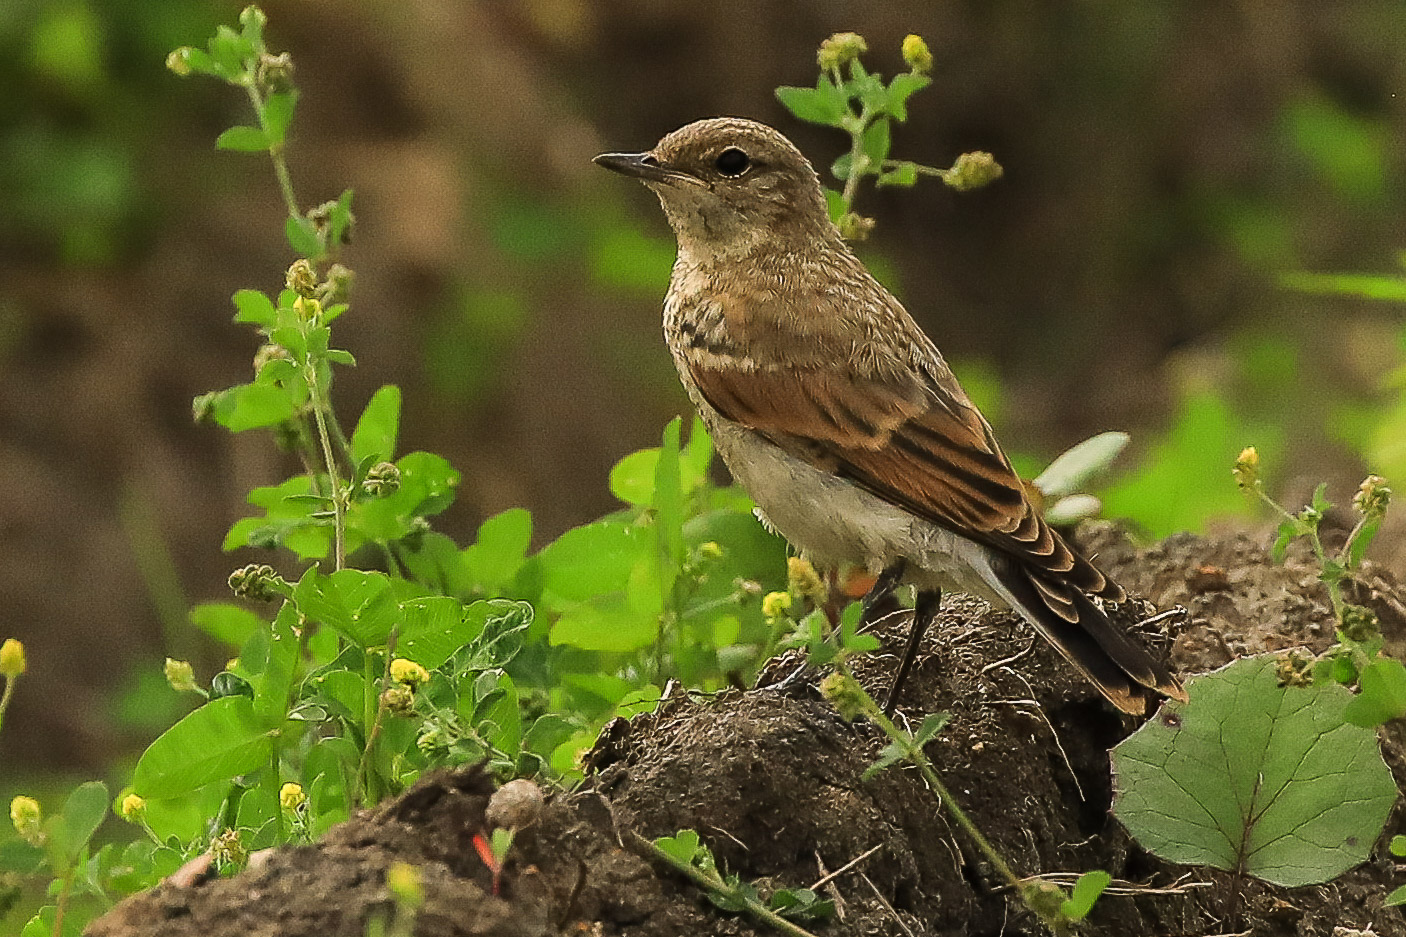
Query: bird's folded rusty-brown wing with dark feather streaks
690 362 1123 601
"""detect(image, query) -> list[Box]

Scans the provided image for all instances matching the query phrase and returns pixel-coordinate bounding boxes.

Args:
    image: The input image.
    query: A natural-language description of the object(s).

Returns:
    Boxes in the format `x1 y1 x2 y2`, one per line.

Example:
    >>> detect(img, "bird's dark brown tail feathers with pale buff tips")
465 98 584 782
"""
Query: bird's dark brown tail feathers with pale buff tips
991 551 1187 716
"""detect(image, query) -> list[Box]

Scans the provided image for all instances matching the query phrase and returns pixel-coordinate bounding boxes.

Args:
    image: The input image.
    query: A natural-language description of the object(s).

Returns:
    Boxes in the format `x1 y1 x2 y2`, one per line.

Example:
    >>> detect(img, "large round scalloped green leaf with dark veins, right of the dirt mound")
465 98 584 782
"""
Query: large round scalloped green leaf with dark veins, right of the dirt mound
1112 654 1398 888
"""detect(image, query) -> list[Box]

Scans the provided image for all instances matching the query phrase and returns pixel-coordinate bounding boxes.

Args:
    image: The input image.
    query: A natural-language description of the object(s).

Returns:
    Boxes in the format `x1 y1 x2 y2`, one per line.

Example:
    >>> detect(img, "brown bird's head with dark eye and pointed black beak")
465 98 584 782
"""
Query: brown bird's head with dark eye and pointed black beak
595 117 838 259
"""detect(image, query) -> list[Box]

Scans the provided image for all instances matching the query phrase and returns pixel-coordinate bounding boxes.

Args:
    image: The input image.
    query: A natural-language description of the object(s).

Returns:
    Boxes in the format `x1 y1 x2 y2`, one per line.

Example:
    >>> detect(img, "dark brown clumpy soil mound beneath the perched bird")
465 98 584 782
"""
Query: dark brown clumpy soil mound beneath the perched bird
90 529 1406 937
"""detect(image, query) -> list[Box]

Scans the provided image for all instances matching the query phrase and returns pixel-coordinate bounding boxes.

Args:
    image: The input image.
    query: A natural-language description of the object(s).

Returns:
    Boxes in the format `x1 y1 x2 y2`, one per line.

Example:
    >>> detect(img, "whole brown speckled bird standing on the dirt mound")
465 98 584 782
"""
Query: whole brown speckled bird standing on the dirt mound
595 118 1185 713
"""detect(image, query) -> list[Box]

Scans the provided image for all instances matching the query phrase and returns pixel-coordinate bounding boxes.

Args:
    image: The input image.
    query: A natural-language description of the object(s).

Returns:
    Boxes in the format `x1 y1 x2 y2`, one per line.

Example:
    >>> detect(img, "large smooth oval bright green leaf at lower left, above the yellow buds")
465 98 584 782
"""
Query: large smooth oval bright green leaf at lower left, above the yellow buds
132 696 273 798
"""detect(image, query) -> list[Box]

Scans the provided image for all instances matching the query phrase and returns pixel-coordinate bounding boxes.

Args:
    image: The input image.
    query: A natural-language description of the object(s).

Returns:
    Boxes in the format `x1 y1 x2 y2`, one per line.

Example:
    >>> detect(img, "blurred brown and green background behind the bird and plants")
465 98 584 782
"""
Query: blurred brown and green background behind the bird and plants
0 0 1406 796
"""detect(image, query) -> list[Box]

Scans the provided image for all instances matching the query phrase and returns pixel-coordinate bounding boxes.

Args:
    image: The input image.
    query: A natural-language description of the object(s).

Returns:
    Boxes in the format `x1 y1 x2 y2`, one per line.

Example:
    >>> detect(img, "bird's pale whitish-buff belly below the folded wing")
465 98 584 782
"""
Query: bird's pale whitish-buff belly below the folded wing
704 412 1004 605
